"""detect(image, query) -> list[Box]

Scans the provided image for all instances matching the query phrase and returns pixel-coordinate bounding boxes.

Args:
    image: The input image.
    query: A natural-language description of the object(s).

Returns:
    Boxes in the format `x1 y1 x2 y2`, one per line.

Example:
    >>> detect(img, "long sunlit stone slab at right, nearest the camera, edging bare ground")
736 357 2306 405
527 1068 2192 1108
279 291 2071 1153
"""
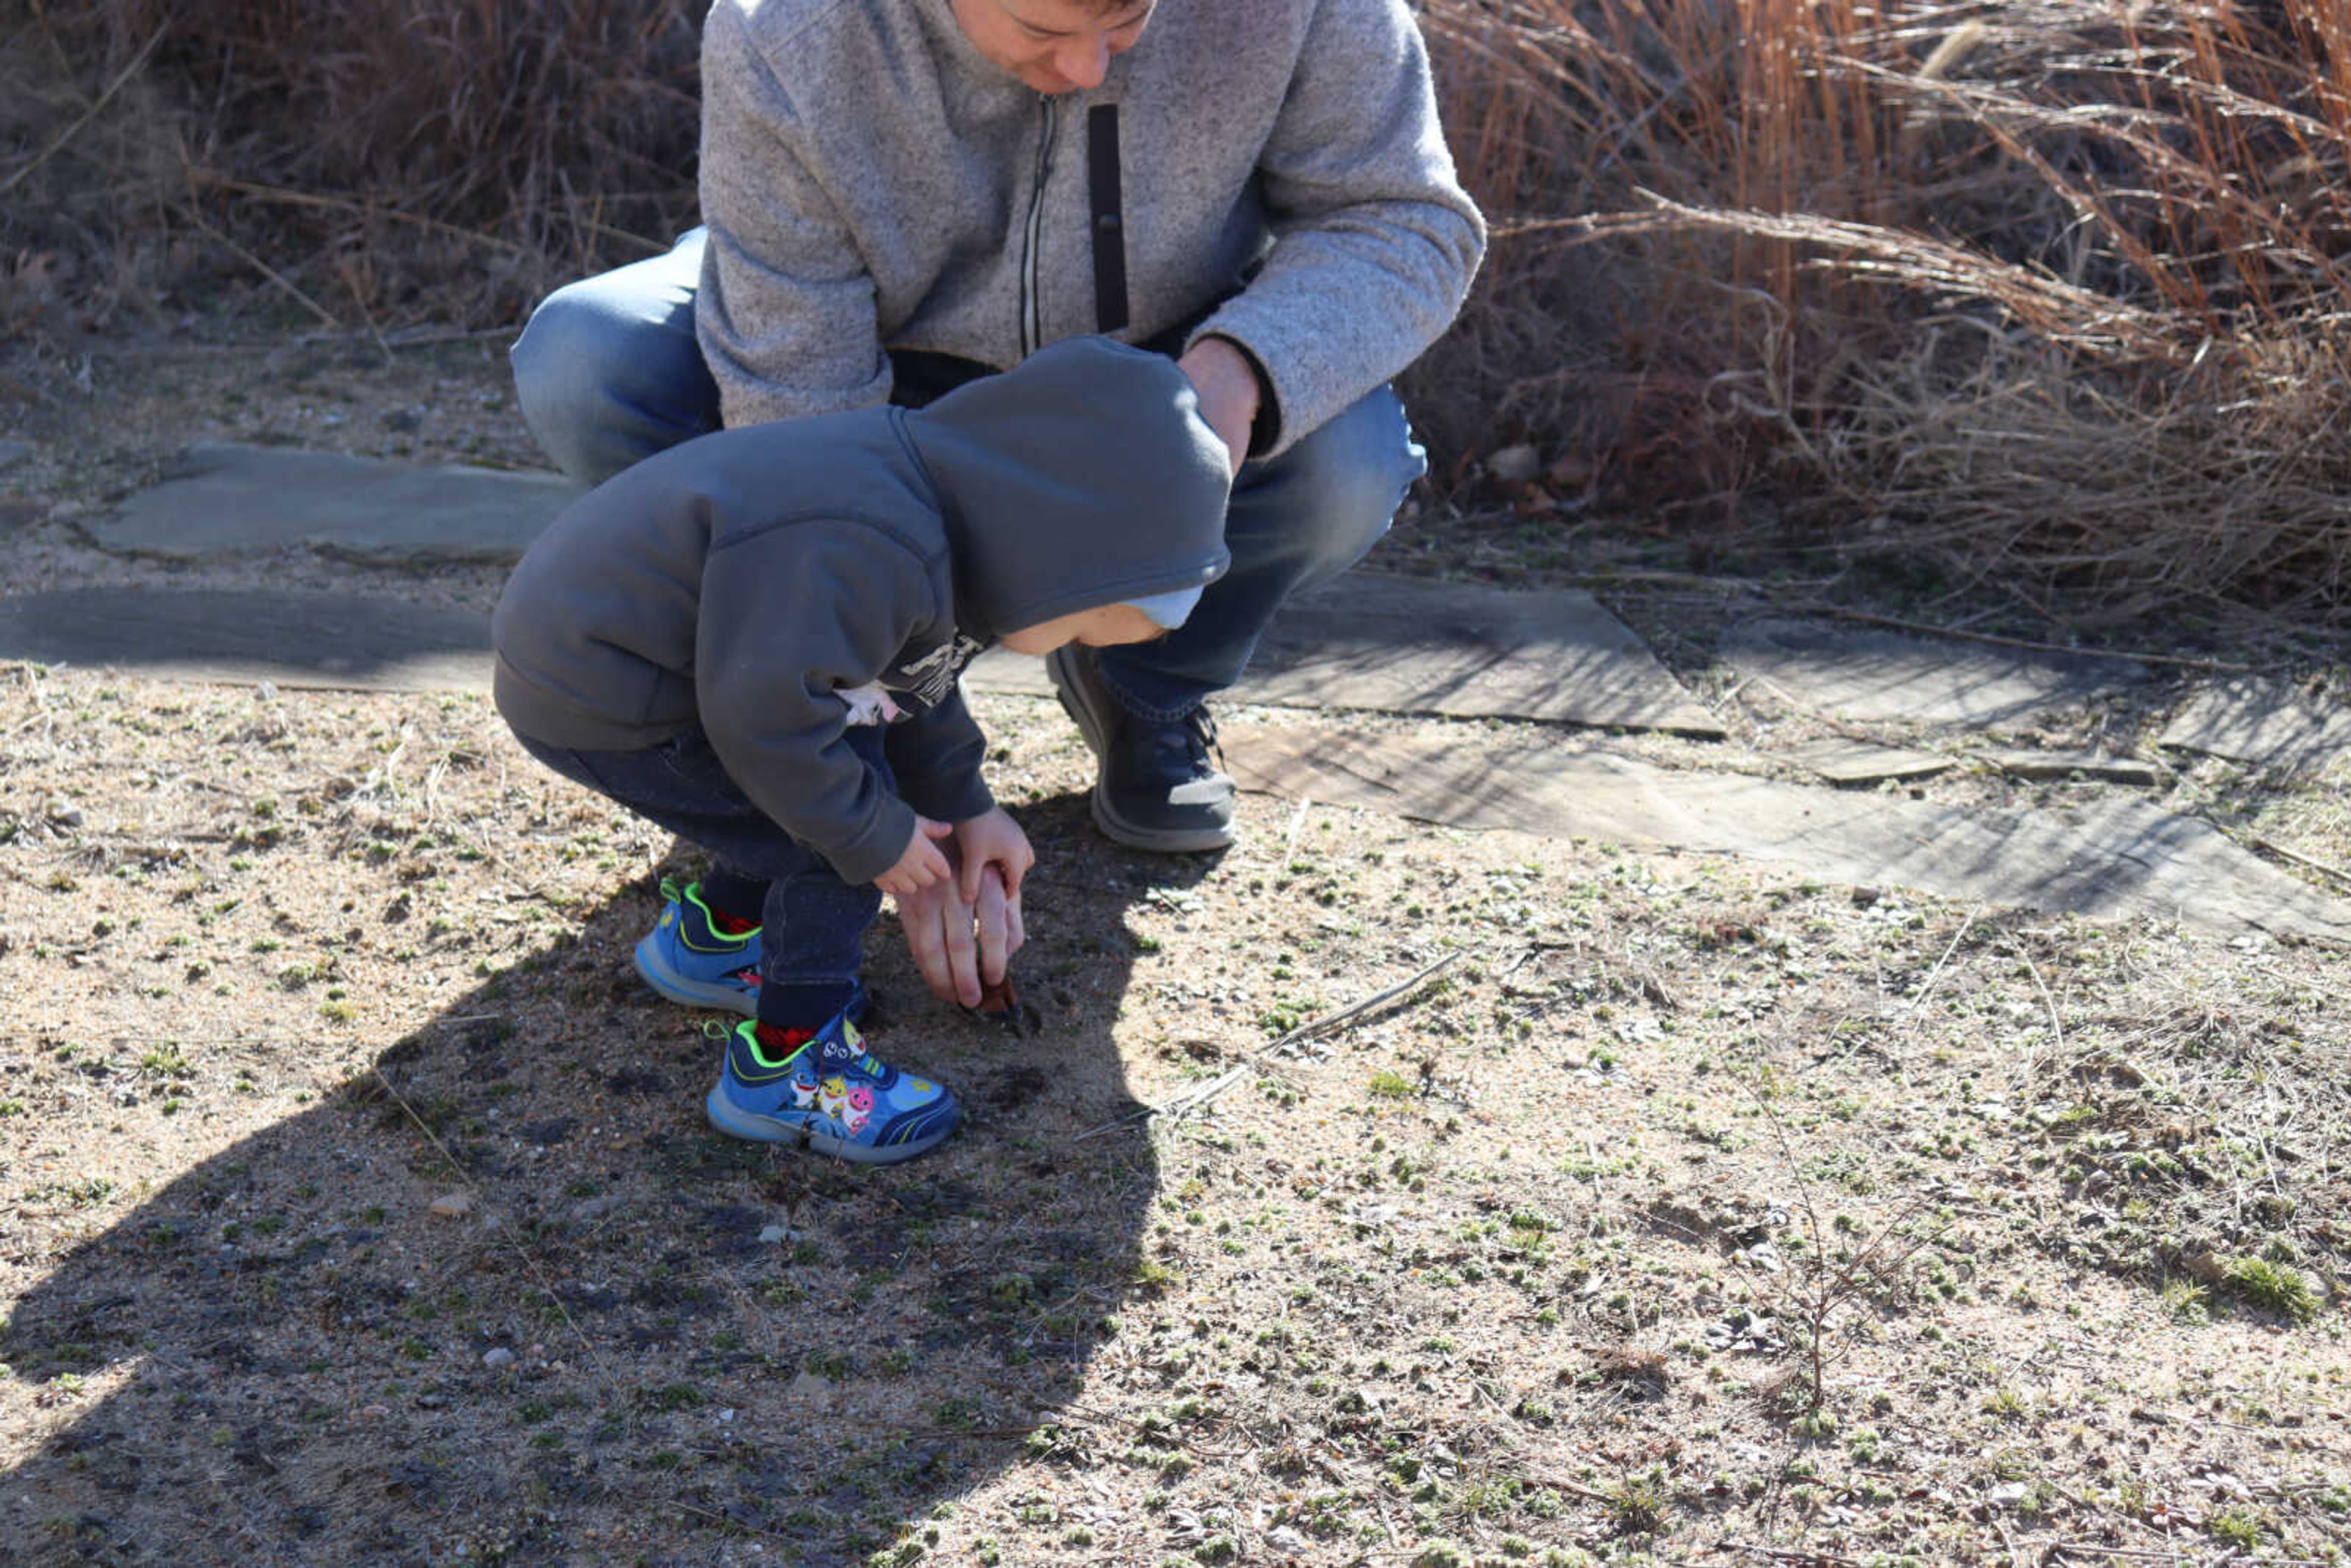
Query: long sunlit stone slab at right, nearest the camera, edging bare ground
1225 726 2351 943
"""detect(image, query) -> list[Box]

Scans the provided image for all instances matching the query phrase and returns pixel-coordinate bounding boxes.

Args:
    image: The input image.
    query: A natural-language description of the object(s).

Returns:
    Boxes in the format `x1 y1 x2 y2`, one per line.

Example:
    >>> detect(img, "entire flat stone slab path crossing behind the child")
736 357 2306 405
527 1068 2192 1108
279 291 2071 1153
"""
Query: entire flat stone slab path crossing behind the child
0 447 2351 943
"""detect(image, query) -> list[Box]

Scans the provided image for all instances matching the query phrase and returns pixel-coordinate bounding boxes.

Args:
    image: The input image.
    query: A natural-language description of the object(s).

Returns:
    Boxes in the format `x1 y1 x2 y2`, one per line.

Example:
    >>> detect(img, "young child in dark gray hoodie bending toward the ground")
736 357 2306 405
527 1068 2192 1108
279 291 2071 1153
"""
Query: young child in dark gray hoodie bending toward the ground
492 339 1229 1161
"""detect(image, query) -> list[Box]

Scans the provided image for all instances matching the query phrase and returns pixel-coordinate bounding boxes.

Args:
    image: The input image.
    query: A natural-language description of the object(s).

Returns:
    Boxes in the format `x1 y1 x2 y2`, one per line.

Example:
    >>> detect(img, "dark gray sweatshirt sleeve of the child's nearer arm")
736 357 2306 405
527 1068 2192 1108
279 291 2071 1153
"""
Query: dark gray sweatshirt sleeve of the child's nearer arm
694 522 938 882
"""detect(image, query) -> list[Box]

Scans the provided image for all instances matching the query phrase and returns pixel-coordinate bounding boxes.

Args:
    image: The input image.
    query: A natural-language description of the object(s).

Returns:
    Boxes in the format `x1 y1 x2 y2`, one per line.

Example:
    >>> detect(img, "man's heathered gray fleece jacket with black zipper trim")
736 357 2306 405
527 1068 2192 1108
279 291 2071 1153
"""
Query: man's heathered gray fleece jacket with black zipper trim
696 0 1486 456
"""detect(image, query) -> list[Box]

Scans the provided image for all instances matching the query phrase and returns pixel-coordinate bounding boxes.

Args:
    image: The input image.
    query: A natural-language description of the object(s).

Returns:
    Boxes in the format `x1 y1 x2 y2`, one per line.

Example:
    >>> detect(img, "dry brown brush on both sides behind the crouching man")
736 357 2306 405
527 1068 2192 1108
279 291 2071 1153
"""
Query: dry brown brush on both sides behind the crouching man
0 0 2351 625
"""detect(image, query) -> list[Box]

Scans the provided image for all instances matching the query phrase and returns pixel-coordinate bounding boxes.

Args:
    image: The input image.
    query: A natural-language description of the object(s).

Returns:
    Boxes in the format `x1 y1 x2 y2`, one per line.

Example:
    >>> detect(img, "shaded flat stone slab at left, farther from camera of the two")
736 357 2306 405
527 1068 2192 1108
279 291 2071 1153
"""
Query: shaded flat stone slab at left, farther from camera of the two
89 445 579 562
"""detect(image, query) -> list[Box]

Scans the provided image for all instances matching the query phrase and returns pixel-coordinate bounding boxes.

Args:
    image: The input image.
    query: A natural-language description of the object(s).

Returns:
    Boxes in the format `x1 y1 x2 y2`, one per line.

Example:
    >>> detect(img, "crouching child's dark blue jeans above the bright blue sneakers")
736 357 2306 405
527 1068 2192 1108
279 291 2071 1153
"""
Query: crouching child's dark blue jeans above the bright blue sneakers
515 724 893 1025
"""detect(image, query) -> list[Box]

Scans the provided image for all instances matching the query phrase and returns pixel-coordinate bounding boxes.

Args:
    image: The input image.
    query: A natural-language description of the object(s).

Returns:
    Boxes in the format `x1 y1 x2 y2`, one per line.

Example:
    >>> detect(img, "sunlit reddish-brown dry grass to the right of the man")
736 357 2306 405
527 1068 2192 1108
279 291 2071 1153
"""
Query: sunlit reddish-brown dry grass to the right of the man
1418 0 2351 621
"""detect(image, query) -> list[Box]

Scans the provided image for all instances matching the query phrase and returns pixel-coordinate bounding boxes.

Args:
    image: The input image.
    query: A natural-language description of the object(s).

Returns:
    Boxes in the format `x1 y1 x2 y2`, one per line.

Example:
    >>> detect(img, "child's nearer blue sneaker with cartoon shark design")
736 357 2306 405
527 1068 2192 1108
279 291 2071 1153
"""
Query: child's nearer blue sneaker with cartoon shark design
705 1013 964 1166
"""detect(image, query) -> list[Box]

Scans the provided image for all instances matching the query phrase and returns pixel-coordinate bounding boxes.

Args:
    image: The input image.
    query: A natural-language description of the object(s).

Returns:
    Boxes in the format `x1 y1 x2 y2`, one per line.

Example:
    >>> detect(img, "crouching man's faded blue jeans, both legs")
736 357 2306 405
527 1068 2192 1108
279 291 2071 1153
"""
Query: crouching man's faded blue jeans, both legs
512 228 1427 722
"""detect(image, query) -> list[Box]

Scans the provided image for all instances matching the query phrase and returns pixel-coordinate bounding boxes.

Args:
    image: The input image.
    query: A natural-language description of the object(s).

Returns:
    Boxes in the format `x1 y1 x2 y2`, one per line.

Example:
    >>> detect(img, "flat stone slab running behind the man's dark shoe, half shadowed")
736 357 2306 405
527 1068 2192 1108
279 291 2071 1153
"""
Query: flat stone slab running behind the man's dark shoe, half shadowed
966 574 1723 738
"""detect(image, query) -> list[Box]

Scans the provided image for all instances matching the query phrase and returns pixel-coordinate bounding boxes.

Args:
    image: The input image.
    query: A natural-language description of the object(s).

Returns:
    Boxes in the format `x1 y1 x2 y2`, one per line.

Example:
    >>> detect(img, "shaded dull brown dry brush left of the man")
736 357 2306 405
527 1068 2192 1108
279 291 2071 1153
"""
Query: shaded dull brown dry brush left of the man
0 0 698 329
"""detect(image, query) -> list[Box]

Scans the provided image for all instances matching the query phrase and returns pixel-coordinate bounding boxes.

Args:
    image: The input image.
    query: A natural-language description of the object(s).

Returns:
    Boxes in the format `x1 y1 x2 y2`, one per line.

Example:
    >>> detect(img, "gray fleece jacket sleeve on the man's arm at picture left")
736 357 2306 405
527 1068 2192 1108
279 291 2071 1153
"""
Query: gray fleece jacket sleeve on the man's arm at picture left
694 5 891 430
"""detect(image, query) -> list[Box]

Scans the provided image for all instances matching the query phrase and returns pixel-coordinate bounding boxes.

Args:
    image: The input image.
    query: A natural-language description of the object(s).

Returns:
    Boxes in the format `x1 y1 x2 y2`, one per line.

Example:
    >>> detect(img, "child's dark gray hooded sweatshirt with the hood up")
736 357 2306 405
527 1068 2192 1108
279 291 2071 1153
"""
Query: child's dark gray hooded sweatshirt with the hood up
492 339 1229 882
